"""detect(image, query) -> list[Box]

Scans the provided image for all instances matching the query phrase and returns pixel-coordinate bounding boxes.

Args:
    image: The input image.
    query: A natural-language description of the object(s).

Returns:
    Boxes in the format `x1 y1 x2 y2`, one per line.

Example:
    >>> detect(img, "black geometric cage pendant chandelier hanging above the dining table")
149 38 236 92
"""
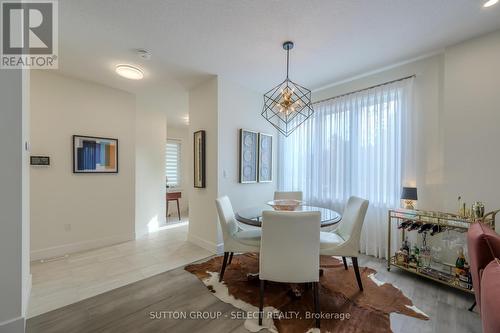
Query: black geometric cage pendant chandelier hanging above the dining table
261 41 314 136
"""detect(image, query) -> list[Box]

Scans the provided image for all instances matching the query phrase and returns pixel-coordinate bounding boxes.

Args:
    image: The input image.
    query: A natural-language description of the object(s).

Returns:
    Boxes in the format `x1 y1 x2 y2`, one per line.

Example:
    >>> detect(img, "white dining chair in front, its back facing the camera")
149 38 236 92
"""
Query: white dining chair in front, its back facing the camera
259 211 321 327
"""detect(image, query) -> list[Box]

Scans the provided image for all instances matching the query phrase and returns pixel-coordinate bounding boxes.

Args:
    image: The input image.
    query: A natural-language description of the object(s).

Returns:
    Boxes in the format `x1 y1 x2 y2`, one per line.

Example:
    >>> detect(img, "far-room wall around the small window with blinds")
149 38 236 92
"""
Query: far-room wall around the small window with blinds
167 125 193 215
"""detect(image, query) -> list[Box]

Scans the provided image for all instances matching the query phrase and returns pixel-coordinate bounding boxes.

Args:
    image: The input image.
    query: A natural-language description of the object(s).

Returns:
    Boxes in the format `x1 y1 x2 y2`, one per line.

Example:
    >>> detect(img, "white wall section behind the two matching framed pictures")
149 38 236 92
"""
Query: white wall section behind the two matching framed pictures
218 77 278 211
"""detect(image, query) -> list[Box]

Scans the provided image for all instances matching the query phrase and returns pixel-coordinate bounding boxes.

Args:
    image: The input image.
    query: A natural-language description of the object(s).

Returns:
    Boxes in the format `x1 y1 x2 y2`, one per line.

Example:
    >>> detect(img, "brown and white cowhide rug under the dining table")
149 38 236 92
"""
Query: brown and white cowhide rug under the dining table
185 253 429 333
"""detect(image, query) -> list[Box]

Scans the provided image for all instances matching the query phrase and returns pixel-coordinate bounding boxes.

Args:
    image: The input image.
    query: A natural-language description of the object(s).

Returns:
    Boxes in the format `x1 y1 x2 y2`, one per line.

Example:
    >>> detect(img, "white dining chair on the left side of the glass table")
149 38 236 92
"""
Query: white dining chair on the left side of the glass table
215 196 261 282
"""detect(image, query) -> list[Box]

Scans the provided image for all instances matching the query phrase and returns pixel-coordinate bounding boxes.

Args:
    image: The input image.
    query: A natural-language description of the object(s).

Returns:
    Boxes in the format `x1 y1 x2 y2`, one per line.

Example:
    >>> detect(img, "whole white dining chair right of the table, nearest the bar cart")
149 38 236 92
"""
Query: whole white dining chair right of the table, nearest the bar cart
320 197 369 291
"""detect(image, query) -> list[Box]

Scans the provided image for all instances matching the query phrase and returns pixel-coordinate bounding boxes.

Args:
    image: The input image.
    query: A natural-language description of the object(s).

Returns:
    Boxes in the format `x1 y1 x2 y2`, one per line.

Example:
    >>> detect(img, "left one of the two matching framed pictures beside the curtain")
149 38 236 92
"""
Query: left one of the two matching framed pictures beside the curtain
240 129 259 184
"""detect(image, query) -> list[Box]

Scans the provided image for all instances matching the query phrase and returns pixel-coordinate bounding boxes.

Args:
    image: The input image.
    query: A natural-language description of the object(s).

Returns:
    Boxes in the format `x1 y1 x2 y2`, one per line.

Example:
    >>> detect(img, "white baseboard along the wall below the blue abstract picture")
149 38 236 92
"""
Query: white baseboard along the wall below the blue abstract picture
31 233 135 261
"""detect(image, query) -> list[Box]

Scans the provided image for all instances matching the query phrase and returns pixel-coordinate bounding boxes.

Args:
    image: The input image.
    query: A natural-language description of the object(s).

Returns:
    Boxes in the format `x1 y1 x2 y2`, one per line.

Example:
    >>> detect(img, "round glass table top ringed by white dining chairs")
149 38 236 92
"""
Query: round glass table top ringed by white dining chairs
235 204 342 227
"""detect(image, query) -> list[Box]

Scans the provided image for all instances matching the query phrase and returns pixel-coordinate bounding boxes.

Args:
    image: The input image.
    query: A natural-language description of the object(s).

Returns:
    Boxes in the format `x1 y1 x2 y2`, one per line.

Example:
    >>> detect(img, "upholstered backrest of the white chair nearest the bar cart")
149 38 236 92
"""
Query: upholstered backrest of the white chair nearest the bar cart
335 197 368 247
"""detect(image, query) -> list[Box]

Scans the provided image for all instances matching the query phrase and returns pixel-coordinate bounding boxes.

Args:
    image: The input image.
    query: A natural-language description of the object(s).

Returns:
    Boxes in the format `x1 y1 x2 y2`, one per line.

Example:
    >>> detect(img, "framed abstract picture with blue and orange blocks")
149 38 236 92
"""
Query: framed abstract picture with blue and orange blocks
73 135 118 173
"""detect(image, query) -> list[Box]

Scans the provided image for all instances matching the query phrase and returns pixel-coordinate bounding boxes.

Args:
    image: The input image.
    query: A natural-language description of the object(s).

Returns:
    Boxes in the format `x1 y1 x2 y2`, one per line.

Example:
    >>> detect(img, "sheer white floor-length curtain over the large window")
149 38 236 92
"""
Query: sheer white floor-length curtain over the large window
278 78 414 258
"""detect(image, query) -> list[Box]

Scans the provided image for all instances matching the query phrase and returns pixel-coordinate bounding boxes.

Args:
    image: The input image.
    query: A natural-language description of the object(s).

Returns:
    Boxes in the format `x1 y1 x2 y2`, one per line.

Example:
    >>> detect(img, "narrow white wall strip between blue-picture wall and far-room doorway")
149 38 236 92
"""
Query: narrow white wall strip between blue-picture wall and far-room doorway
135 94 168 237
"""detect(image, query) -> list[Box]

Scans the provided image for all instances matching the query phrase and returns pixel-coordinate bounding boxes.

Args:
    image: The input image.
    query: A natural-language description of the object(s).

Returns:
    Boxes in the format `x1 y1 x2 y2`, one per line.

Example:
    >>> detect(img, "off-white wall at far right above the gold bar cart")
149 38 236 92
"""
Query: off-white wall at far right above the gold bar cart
444 31 500 217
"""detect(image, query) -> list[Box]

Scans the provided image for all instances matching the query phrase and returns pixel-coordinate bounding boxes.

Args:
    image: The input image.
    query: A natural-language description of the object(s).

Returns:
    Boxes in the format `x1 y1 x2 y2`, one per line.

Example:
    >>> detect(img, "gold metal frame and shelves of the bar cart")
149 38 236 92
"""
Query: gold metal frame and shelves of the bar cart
387 209 500 294
